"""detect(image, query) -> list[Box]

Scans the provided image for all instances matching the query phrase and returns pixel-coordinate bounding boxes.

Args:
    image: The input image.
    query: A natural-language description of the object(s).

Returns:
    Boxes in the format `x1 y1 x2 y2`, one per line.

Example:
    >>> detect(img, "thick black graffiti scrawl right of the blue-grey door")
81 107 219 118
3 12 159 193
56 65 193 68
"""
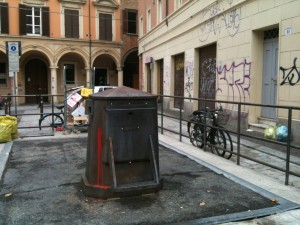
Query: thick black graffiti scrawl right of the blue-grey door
280 58 300 86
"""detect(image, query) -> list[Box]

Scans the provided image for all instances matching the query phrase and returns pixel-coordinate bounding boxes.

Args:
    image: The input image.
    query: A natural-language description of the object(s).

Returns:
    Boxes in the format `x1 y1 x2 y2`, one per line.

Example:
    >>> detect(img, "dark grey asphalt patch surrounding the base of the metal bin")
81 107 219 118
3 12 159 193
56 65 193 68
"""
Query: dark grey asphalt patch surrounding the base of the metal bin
0 138 284 225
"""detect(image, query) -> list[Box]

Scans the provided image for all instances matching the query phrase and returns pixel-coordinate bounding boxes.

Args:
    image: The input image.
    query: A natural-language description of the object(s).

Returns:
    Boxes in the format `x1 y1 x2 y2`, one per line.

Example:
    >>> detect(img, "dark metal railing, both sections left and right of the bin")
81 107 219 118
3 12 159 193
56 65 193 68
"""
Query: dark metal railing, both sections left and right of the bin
2 92 300 185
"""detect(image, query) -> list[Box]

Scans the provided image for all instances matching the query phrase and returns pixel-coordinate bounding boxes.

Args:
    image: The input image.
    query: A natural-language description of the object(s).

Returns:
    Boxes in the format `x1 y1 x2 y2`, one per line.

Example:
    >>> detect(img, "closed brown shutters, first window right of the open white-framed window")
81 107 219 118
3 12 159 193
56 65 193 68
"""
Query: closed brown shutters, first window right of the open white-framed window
65 9 79 38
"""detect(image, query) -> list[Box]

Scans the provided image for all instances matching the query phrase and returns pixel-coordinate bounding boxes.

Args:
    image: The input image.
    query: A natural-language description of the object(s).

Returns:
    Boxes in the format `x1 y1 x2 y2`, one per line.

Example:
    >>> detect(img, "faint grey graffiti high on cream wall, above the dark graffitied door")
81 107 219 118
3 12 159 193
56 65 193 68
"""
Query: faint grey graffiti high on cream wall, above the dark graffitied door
200 0 241 42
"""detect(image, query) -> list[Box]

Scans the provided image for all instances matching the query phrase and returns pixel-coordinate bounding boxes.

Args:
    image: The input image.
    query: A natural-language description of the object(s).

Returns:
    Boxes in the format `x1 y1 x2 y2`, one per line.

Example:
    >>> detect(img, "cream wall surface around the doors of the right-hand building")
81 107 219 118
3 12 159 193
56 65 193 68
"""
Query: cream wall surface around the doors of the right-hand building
139 0 300 120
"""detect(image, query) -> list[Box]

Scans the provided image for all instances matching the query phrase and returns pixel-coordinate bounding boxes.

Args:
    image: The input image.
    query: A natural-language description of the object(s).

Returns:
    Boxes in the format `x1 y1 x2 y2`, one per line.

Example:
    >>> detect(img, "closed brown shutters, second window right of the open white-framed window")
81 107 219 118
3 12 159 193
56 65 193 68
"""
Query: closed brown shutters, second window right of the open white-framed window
99 13 112 41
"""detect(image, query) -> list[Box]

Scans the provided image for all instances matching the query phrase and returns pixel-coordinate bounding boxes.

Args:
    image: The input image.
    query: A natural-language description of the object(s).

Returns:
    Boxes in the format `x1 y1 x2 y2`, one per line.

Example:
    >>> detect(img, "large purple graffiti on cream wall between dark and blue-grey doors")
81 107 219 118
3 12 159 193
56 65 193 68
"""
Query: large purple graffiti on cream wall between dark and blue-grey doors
216 59 251 114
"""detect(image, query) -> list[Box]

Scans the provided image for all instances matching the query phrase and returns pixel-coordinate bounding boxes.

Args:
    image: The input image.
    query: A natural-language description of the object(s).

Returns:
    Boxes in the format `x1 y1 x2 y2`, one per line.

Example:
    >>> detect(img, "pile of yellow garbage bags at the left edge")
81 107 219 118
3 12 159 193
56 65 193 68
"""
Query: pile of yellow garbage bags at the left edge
0 116 18 143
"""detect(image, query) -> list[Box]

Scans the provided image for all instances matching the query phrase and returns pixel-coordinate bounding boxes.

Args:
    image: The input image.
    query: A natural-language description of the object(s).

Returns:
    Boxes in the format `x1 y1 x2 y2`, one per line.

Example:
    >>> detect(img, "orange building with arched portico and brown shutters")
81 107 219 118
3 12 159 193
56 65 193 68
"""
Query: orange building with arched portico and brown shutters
0 0 139 104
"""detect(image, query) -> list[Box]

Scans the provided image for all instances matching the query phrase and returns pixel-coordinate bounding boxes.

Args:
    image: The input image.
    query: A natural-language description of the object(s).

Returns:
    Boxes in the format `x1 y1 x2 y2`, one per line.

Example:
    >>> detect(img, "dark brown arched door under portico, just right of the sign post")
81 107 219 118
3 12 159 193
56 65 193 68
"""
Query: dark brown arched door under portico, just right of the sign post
25 59 48 104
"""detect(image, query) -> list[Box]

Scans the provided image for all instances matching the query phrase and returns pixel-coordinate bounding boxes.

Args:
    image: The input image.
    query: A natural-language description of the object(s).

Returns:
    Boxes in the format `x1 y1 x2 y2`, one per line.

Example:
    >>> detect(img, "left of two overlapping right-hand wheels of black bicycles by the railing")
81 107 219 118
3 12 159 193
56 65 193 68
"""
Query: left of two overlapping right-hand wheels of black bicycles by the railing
207 129 227 157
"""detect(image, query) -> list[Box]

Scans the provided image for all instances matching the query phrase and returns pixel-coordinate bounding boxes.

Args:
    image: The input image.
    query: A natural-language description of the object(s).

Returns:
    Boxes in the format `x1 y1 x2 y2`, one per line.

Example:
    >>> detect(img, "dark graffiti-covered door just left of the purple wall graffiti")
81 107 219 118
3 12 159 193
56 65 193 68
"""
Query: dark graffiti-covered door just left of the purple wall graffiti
198 44 216 109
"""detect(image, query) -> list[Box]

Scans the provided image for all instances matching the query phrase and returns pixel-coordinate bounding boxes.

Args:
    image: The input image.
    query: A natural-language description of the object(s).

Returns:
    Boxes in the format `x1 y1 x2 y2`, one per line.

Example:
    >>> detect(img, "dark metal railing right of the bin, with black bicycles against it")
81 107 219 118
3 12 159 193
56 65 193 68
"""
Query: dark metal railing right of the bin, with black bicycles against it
158 95 300 185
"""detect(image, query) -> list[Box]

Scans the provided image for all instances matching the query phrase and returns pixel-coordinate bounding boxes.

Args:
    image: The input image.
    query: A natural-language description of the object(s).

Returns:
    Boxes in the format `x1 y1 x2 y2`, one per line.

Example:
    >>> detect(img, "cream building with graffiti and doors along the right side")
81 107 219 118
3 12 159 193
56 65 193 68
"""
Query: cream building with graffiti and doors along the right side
139 0 300 133
